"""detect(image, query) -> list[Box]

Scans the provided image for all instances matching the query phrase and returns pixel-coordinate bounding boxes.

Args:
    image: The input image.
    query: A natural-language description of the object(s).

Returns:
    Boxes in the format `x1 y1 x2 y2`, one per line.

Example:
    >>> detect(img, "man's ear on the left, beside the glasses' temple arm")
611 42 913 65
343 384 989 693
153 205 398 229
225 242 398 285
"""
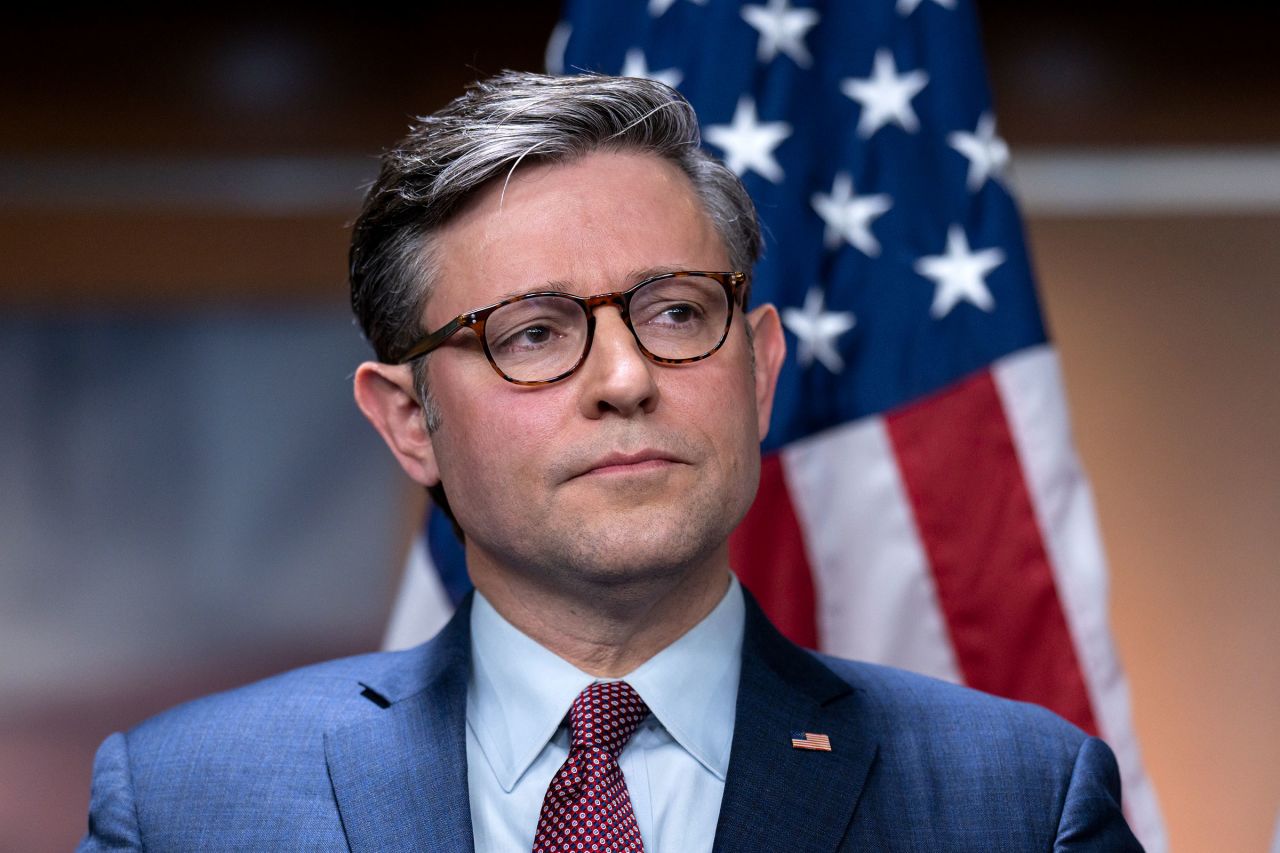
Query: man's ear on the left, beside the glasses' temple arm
355 361 440 487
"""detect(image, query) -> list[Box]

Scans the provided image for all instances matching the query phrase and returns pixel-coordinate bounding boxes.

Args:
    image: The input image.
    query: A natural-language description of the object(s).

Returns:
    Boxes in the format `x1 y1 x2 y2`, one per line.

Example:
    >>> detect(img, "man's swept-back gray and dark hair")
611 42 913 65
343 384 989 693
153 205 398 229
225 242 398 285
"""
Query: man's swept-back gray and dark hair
349 72 760 368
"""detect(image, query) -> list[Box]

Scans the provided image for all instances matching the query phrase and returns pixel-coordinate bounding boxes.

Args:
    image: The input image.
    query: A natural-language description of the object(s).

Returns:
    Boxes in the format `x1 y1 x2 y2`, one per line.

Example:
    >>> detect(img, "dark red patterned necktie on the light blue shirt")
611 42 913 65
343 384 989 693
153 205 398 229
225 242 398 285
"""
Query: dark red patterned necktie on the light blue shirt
534 681 649 853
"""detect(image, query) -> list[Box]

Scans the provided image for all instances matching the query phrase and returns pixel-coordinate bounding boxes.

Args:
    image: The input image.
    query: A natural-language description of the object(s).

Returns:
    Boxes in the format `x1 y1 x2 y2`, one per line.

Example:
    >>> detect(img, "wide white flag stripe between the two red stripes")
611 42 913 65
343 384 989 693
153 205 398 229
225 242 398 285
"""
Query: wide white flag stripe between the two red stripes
782 418 961 681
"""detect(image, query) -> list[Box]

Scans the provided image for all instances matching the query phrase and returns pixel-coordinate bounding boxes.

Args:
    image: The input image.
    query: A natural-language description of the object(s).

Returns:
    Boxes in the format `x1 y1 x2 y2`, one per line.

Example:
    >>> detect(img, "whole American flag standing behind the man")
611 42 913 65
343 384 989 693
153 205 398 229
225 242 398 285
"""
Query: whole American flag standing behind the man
378 0 1166 850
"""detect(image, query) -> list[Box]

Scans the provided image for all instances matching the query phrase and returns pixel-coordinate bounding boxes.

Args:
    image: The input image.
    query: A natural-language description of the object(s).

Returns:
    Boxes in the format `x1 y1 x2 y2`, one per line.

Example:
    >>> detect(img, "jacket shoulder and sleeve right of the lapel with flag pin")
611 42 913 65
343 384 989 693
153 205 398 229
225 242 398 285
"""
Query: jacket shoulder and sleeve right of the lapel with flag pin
817 654 1142 850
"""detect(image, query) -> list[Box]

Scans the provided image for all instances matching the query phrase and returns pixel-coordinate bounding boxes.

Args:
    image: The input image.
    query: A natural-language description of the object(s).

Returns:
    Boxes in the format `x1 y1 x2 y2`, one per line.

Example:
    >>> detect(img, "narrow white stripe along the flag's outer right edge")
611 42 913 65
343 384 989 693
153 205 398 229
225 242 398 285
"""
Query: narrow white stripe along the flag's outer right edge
992 346 1169 853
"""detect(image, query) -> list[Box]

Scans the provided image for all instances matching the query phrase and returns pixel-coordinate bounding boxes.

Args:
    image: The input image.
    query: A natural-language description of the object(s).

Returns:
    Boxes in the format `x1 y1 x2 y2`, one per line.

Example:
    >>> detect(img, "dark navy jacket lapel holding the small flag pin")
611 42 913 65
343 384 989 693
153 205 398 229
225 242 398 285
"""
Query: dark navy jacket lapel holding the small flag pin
714 596 877 853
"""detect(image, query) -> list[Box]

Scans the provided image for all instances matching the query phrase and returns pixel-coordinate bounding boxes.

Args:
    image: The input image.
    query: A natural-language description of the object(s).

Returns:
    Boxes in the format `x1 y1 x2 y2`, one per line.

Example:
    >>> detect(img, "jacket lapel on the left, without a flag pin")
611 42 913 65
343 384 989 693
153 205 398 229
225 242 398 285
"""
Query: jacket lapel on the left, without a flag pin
325 597 474 853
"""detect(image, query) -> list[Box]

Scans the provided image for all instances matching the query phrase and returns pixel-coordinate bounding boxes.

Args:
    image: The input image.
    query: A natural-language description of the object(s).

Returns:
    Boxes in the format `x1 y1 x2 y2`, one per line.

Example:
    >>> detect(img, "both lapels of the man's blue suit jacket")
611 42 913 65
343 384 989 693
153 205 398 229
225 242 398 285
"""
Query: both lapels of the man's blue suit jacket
325 590 877 853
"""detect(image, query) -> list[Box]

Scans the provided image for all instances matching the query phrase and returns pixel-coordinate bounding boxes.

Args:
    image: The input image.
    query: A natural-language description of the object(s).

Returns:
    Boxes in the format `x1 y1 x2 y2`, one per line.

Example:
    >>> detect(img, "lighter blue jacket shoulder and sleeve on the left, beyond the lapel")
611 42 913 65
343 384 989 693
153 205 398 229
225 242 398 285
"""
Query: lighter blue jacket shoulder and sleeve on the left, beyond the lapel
82 652 424 849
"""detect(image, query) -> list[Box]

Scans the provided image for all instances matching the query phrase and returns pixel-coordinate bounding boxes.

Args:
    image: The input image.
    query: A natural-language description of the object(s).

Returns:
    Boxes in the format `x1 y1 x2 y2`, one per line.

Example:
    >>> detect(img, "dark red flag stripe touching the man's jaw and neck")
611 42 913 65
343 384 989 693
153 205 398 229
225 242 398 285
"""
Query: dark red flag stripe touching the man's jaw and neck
728 453 818 648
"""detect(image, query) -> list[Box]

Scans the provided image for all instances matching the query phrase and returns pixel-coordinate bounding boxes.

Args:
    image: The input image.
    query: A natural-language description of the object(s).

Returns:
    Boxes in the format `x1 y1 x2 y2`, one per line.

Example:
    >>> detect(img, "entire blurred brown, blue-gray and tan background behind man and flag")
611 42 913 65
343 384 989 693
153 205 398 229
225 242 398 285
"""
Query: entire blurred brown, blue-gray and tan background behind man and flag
0 0 1280 850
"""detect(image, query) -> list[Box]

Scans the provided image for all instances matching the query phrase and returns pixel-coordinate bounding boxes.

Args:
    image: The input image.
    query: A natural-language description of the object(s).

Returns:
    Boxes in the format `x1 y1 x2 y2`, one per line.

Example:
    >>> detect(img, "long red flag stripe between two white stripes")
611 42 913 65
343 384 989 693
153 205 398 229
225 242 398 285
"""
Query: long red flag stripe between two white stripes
886 371 1097 734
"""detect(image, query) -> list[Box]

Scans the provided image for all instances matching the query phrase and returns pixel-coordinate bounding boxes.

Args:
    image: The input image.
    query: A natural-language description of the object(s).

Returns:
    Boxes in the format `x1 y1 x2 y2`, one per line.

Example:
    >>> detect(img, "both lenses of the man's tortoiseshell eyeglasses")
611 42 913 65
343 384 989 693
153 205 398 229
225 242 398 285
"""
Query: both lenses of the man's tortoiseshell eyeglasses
485 275 730 382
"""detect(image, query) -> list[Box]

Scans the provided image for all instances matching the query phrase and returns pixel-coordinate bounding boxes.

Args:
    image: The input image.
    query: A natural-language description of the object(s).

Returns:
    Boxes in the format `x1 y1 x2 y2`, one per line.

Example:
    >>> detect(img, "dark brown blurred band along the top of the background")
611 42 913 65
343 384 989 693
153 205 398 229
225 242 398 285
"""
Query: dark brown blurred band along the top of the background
0 0 1280 156
